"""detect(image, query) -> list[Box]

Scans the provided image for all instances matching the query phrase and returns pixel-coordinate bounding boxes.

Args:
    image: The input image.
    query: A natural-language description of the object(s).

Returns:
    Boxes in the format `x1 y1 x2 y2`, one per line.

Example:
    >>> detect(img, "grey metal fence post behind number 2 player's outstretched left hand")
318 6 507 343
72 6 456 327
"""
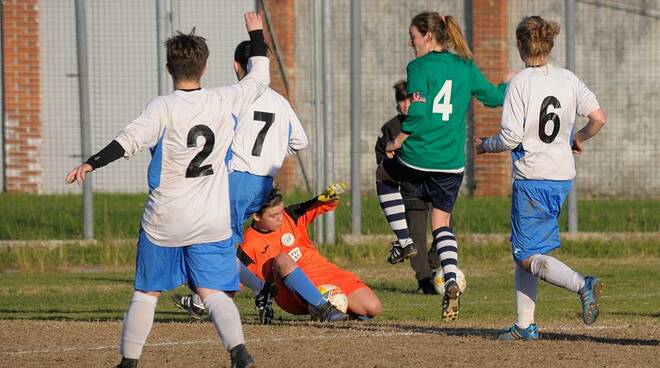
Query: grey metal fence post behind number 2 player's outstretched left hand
76 0 94 239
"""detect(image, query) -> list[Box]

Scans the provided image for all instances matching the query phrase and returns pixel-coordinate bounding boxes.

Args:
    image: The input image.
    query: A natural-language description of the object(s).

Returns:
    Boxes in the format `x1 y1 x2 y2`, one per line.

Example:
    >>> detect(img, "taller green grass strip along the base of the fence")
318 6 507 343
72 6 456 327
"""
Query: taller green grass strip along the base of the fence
0 193 660 240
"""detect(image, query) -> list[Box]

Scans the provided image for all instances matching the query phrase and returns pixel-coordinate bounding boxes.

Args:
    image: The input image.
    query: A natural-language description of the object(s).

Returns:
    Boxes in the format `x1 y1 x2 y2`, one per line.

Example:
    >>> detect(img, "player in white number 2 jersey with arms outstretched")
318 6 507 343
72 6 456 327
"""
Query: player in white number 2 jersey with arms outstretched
66 12 269 368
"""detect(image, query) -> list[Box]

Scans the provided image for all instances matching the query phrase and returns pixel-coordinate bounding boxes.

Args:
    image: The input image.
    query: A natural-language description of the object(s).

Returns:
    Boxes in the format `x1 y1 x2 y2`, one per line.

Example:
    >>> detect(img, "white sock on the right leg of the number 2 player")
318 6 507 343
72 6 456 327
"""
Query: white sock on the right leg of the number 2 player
204 291 245 351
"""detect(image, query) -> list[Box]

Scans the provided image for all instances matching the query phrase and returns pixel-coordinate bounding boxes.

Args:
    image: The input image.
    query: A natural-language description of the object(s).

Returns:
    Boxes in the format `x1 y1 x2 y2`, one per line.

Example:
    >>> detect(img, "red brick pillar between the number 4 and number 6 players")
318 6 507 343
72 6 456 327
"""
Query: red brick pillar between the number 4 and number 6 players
472 0 511 196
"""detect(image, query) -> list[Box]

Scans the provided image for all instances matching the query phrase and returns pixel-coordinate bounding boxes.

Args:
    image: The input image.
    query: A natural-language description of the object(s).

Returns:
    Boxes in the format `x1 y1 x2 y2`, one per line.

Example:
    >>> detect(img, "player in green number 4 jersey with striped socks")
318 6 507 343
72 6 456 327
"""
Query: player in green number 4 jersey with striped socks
376 12 506 320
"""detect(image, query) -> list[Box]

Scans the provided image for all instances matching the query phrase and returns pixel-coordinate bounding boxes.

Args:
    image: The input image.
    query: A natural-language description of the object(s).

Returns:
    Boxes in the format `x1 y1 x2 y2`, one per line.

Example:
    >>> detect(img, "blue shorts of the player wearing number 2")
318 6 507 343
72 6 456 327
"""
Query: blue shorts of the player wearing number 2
134 229 239 292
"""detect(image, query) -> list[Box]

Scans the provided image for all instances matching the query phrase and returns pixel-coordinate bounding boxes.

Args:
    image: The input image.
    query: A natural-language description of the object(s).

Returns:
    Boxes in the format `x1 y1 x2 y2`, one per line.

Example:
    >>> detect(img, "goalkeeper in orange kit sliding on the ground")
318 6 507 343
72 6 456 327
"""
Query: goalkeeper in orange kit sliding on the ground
238 184 381 321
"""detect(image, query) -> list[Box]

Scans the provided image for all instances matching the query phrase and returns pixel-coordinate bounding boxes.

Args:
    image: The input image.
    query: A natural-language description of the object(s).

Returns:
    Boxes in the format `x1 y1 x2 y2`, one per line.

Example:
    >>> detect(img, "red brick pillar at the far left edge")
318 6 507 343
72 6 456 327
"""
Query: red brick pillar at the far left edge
2 0 42 192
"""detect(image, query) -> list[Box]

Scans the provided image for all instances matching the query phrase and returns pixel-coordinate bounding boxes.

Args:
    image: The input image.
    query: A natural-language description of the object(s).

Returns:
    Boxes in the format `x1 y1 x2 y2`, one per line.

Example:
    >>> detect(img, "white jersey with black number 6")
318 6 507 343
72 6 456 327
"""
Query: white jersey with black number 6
483 64 600 180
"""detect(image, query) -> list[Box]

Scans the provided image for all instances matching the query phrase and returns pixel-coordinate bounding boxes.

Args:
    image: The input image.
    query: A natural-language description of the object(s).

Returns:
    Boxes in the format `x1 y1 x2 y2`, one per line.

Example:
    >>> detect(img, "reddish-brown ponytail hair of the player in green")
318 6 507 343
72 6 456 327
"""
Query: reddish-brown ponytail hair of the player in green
410 11 472 60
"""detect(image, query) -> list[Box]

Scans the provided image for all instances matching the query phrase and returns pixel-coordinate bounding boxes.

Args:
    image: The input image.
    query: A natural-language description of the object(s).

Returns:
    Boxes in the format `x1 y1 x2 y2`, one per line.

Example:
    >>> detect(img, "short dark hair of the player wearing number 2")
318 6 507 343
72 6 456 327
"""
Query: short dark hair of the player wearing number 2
165 27 209 81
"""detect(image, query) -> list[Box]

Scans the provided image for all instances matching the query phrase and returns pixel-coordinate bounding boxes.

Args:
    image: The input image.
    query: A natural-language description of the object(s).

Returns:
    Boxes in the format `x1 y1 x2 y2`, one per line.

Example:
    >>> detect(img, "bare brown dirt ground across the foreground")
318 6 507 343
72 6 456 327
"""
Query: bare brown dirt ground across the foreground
0 316 660 368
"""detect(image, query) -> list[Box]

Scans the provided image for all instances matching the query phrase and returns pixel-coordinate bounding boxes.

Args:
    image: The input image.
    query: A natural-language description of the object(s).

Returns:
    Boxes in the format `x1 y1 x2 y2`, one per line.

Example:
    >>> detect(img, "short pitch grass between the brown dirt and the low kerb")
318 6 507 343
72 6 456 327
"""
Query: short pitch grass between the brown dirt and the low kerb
0 249 660 327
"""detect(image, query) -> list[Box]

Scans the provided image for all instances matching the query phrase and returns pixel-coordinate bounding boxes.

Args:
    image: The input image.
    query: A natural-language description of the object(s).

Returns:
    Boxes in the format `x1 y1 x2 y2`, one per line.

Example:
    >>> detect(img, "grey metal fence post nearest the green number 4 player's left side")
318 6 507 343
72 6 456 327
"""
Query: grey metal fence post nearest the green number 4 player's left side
351 0 362 235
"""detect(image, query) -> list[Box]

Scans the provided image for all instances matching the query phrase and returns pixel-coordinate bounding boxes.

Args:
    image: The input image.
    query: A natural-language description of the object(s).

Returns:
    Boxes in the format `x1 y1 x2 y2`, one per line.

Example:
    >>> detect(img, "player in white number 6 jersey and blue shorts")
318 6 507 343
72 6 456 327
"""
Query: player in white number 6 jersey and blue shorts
474 16 606 340
